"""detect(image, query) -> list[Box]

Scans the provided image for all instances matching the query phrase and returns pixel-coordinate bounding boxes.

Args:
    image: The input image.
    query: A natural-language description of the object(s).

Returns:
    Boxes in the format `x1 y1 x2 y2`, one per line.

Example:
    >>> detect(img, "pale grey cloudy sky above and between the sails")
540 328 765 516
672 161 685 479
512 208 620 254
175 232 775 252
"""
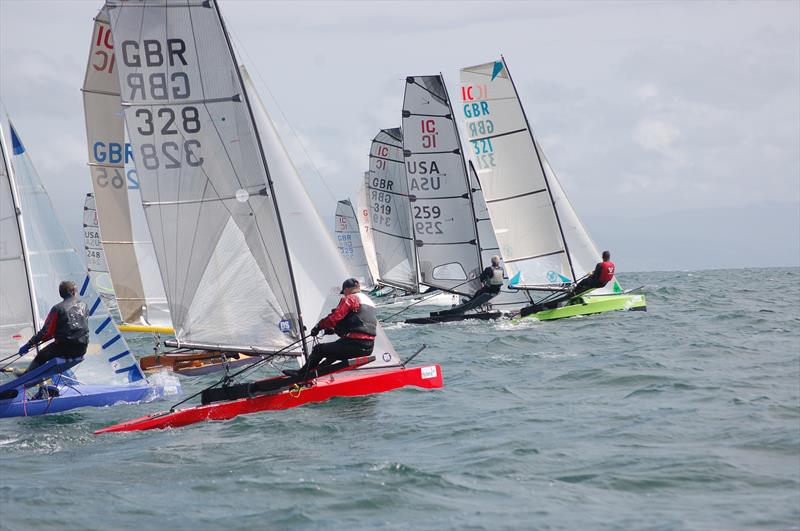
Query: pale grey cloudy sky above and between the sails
0 0 800 272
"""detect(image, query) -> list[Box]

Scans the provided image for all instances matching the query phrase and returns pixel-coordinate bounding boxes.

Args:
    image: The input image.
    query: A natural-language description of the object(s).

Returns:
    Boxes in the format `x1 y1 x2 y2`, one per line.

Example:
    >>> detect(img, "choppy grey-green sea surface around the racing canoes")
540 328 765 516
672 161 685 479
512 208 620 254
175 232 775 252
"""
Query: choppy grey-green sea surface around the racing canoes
0 268 800 530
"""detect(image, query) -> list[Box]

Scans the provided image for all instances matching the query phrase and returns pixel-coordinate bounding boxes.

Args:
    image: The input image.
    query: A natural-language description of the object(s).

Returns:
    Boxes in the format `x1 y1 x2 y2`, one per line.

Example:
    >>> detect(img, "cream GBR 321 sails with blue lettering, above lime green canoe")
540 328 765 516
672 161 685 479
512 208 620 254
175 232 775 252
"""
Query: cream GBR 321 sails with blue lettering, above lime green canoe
461 59 616 294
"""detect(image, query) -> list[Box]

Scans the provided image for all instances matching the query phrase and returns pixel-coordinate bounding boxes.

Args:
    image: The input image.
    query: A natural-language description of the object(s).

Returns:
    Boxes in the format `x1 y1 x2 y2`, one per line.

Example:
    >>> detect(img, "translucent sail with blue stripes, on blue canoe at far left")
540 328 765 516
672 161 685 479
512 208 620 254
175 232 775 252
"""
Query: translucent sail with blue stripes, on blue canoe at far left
0 115 147 385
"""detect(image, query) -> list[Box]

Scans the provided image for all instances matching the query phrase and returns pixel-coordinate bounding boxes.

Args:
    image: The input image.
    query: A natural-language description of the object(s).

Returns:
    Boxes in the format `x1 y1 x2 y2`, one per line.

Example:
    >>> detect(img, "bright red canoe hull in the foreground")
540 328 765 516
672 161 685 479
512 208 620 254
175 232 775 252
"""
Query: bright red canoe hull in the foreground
94 365 444 435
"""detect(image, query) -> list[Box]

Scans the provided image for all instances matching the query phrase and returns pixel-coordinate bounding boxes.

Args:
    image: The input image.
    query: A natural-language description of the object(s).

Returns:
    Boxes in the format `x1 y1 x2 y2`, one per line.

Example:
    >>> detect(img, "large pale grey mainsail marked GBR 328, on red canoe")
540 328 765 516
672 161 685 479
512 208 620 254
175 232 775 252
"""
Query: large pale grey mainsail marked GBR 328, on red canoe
106 0 302 349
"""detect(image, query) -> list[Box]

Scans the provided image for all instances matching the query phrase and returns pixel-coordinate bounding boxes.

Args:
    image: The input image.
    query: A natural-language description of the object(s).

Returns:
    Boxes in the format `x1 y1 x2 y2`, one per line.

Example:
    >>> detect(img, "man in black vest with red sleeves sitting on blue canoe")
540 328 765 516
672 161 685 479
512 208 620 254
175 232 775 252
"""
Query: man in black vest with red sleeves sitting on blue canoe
18 280 89 375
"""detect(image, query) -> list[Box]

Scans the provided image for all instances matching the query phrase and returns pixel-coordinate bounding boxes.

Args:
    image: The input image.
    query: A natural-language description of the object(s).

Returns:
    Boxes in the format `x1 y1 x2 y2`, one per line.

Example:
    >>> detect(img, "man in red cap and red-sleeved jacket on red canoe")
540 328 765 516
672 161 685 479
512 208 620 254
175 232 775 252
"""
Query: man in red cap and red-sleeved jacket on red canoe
283 278 378 377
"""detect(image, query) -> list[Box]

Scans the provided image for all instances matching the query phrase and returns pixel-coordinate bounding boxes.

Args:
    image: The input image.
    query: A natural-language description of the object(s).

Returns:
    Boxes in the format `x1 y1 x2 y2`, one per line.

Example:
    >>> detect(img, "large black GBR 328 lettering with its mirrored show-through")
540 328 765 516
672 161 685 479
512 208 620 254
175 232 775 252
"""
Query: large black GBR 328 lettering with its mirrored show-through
121 39 204 170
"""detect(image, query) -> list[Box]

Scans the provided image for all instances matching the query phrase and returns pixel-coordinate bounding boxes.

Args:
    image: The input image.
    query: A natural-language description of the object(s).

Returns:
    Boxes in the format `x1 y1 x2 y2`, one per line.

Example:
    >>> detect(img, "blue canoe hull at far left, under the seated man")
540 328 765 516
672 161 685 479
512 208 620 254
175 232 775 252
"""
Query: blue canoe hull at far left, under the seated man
0 384 164 418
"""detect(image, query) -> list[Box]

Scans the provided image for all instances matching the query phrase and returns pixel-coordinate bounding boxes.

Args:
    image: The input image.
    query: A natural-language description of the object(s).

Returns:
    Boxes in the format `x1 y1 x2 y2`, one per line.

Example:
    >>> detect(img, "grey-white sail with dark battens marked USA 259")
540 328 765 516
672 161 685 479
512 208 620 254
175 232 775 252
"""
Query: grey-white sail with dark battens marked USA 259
403 75 481 295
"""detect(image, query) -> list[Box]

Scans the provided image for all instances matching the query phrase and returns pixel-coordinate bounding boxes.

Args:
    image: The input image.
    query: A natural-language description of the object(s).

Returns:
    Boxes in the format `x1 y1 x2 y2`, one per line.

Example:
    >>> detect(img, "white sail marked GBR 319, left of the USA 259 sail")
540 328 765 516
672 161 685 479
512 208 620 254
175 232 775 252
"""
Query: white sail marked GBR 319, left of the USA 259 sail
367 128 419 292
